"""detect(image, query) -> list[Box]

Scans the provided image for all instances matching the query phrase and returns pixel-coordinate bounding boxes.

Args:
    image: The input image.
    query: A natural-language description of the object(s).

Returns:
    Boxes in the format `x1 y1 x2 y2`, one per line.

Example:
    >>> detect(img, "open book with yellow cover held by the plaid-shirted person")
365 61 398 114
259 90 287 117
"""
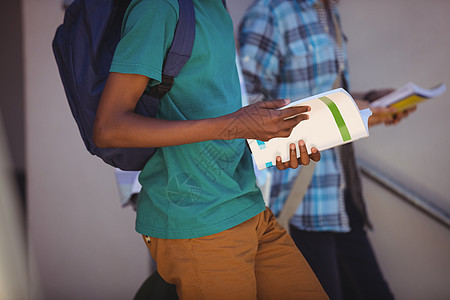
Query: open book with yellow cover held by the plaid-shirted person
370 82 447 110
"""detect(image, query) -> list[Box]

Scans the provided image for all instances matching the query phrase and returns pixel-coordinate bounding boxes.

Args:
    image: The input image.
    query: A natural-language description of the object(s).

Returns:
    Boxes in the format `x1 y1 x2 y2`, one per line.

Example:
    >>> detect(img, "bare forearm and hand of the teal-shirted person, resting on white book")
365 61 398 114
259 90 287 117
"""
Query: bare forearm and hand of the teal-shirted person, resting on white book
93 100 309 148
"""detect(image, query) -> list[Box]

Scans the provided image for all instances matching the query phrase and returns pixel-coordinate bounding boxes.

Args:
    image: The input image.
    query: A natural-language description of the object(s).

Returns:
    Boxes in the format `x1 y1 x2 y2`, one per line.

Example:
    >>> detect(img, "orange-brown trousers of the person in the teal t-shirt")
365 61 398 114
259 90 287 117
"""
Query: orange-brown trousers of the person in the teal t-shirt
144 209 328 300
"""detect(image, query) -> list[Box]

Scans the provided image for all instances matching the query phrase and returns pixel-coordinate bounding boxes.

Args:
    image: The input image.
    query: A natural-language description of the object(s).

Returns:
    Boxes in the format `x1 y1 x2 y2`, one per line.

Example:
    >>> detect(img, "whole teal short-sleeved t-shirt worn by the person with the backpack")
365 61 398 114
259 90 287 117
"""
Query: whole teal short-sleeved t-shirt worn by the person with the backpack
111 0 265 239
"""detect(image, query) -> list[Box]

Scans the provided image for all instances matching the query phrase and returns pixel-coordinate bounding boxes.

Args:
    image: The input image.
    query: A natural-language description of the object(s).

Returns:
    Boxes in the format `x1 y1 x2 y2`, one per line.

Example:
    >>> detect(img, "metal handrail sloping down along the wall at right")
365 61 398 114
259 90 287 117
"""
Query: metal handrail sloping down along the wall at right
358 159 450 229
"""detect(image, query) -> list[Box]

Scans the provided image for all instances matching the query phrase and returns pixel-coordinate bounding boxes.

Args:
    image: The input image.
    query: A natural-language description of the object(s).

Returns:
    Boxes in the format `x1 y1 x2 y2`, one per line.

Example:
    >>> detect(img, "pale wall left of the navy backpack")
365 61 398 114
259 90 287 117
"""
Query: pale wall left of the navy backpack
23 0 149 300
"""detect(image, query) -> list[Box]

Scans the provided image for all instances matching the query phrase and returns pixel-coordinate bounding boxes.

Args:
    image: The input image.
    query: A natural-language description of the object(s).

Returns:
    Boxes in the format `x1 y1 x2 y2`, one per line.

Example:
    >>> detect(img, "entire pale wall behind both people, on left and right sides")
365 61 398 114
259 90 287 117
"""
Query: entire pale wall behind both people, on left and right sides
23 0 450 299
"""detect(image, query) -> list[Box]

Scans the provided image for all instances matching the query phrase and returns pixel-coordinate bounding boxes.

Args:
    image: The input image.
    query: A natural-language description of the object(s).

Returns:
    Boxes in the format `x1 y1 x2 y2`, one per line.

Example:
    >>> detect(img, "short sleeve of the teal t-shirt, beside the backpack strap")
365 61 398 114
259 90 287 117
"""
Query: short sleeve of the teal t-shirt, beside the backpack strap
110 0 178 85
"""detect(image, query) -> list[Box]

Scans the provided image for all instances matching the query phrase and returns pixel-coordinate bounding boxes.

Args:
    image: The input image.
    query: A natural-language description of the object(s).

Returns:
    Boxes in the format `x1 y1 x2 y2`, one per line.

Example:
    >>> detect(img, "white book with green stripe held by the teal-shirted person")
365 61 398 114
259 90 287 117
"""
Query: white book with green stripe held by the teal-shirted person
247 88 372 170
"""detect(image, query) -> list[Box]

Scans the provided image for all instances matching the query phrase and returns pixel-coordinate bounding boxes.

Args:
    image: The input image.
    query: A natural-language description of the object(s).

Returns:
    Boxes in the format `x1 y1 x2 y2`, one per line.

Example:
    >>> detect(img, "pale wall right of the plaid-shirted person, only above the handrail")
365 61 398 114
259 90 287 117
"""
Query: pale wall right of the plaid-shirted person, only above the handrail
341 0 450 211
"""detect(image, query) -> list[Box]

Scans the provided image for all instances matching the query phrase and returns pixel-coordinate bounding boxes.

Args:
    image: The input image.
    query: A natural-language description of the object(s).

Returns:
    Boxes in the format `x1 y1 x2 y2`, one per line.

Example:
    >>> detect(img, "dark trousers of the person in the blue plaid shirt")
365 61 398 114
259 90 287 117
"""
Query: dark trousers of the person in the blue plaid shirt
291 226 394 300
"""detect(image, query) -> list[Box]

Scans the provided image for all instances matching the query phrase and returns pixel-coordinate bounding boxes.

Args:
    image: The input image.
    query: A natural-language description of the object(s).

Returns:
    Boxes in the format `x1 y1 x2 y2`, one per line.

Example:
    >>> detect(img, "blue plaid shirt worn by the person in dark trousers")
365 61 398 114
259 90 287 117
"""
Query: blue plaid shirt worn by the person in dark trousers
239 0 350 232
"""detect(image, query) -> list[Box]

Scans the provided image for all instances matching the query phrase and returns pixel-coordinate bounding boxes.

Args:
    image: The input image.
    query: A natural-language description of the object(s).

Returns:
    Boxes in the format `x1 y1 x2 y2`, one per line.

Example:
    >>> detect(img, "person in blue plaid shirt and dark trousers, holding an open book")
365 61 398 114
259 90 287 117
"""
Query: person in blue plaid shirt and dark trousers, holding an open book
239 0 416 299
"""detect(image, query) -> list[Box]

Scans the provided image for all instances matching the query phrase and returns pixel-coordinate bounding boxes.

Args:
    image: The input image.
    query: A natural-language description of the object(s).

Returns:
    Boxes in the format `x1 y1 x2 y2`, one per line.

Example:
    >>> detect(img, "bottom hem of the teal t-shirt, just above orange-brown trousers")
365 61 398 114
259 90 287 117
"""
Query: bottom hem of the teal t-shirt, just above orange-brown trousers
136 201 266 239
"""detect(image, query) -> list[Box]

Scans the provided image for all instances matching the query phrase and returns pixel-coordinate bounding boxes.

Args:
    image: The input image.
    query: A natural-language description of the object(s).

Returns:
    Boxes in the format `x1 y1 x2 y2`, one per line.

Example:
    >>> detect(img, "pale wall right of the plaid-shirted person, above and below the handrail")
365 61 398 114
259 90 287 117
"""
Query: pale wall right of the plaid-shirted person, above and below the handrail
341 0 450 299
